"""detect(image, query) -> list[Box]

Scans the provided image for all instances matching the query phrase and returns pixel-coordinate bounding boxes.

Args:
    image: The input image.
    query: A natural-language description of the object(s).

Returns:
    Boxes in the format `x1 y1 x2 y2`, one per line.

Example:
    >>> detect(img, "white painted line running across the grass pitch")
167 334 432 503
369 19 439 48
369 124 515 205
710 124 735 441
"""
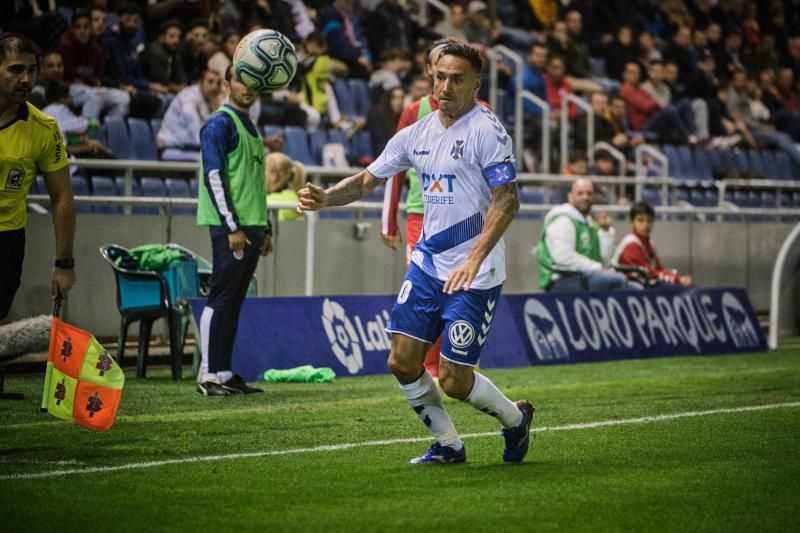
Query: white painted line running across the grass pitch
0 402 800 481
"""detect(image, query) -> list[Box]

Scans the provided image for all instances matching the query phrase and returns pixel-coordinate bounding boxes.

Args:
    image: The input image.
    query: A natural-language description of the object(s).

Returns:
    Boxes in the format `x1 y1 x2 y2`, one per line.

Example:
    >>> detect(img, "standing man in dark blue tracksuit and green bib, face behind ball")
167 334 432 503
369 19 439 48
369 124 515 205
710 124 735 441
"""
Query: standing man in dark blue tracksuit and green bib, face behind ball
197 67 272 396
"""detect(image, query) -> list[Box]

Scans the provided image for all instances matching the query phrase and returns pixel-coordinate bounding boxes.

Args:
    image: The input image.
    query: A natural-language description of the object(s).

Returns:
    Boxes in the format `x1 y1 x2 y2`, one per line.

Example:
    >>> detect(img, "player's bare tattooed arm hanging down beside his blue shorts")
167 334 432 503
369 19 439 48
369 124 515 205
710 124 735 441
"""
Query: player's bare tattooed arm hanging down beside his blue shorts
442 183 519 294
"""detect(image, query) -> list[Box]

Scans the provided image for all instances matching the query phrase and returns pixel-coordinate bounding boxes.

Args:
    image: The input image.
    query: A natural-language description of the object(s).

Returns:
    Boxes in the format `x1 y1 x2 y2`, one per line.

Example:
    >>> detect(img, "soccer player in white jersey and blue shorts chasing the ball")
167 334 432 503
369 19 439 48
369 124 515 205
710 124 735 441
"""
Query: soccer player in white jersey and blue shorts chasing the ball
298 43 534 463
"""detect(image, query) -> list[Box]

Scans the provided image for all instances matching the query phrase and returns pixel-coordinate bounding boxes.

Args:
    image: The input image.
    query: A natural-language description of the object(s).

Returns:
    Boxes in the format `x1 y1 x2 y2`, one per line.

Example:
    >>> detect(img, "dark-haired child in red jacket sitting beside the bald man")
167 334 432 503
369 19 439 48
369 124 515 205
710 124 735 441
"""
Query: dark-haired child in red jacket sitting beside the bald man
611 202 692 287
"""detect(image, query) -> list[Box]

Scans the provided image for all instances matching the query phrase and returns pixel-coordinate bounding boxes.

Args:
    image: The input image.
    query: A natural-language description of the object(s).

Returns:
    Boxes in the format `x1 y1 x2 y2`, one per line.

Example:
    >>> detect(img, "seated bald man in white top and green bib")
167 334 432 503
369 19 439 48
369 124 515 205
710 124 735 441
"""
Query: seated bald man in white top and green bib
534 178 642 291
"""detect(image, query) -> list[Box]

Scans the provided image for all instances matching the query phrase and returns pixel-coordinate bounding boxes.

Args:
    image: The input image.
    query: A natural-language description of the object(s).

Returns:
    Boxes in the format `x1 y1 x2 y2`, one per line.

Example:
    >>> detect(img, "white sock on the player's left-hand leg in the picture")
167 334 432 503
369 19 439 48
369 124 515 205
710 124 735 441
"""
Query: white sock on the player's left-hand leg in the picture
400 370 464 450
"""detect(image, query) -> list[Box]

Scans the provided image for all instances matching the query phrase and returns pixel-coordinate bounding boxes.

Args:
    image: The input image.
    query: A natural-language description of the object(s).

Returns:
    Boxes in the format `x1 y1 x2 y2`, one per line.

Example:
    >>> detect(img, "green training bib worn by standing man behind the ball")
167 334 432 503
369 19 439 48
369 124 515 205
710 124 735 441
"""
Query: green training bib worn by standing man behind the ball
197 106 267 226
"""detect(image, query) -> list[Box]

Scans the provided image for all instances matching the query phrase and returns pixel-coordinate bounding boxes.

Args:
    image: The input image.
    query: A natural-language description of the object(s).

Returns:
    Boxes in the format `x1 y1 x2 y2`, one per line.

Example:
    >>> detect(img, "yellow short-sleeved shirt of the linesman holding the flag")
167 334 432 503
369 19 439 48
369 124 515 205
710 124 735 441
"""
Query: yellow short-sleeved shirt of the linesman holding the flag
0 102 68 231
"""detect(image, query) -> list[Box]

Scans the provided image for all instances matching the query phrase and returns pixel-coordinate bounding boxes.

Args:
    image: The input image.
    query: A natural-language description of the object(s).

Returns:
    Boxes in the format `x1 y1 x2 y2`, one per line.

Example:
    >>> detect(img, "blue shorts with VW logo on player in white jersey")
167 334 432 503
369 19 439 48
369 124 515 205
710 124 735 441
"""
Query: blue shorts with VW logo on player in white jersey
386 263 502 366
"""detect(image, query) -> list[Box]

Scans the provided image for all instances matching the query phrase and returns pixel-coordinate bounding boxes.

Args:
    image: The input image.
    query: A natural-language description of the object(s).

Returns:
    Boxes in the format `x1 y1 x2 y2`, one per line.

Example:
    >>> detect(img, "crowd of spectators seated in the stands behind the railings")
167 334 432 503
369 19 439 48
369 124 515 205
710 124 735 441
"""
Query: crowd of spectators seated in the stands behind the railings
0 0 800 175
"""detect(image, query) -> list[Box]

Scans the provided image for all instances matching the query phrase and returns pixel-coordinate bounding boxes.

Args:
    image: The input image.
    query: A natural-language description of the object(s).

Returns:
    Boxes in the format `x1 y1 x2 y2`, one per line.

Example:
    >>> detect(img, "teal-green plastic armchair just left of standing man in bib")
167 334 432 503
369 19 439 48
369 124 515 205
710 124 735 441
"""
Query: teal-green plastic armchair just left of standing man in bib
100 244 200 380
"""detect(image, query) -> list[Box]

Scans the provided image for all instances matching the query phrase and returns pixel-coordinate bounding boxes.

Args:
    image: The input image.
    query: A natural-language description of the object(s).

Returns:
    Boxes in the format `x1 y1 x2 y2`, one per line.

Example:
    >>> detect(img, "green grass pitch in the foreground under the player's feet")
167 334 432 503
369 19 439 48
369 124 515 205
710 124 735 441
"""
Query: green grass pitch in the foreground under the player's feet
0 348 800 533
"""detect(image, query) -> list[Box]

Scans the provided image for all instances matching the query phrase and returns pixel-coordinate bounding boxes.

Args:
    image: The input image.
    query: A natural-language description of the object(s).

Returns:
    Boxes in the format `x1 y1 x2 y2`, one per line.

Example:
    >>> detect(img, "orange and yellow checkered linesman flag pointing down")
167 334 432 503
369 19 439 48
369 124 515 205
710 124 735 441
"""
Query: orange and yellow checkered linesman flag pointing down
42 313 125 431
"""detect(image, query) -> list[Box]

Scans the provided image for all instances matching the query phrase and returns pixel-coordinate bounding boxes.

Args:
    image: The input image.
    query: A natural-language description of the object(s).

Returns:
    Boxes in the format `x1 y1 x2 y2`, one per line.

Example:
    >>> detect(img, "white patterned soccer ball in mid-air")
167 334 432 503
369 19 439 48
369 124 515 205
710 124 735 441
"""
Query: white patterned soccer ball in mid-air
233 30 297 94
